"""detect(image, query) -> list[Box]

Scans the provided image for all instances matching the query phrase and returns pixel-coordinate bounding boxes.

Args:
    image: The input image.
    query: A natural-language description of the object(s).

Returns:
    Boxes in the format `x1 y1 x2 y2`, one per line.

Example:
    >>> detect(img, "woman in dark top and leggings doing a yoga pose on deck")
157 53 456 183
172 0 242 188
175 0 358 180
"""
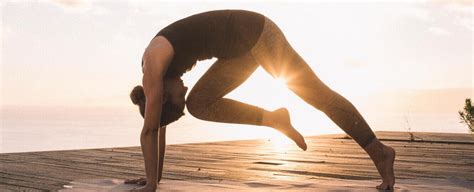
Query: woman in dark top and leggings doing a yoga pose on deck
127 10 395 191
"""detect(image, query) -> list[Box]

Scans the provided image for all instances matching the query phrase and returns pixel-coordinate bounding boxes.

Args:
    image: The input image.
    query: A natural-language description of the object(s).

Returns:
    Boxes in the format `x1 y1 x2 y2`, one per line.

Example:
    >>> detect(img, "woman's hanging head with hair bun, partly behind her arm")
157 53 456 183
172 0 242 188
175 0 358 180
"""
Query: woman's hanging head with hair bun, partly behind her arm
130 77 188 126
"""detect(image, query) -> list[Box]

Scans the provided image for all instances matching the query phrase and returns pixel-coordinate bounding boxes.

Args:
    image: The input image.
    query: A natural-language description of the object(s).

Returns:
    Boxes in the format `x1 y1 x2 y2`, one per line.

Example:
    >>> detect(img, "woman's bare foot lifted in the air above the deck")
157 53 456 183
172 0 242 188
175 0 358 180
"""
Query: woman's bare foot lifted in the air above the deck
262 108 307 151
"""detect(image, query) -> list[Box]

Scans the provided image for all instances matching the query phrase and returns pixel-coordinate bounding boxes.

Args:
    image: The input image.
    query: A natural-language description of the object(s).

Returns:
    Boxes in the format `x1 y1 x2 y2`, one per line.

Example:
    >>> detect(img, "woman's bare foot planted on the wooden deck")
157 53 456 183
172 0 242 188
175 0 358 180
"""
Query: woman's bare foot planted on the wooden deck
365 140 396 190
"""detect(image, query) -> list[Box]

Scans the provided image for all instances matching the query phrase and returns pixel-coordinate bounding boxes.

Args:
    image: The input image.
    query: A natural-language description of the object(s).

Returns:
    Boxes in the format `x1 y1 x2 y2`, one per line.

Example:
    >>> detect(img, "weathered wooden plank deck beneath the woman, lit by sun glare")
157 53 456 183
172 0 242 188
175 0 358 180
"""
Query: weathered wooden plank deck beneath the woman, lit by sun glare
0 132 474 191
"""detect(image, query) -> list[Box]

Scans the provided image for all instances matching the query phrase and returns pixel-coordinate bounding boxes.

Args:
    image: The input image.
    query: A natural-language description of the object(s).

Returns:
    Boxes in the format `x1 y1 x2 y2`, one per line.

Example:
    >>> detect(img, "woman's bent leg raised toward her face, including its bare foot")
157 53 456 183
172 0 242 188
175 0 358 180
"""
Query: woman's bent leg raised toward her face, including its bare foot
186 53 306 150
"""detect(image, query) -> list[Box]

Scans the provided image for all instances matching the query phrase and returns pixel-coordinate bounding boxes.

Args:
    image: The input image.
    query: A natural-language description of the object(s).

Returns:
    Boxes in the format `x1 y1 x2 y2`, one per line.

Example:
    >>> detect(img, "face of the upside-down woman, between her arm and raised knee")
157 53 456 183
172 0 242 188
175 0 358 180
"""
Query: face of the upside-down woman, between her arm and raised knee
165 77 188 109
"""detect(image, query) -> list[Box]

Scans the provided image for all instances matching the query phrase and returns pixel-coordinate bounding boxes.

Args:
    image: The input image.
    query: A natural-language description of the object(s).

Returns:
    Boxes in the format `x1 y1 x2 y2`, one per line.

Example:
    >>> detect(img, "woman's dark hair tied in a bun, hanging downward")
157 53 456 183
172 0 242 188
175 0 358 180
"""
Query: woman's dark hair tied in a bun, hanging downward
130 85 184 127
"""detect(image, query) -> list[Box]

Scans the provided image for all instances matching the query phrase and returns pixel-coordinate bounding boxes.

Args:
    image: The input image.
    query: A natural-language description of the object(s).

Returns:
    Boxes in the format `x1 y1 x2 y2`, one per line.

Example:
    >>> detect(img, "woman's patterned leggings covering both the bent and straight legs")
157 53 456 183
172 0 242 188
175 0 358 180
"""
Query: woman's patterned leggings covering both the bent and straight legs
186 18 376 148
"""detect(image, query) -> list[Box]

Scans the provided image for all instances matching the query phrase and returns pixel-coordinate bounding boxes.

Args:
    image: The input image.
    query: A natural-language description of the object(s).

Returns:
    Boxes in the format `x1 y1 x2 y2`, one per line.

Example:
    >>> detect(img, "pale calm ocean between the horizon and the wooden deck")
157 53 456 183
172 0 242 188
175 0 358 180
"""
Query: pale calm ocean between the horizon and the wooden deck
0 106 469 153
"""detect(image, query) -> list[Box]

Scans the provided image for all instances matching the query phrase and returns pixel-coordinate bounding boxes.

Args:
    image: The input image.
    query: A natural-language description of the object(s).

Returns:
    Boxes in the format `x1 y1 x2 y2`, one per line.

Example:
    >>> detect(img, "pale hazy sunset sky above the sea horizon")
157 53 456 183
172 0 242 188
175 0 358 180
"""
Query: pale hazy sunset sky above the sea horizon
0 0 474 114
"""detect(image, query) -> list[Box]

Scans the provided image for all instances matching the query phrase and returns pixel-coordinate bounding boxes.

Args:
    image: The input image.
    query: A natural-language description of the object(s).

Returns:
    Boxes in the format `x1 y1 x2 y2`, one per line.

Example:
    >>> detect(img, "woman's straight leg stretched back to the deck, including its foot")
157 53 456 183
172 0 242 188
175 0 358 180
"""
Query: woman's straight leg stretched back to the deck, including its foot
251 19 395 188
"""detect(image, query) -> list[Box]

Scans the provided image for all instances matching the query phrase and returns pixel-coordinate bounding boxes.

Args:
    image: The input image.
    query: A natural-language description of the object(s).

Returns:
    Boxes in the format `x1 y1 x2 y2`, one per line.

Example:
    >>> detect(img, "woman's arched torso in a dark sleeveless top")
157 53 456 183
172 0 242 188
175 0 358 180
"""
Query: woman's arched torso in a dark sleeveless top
156 10 265 76
